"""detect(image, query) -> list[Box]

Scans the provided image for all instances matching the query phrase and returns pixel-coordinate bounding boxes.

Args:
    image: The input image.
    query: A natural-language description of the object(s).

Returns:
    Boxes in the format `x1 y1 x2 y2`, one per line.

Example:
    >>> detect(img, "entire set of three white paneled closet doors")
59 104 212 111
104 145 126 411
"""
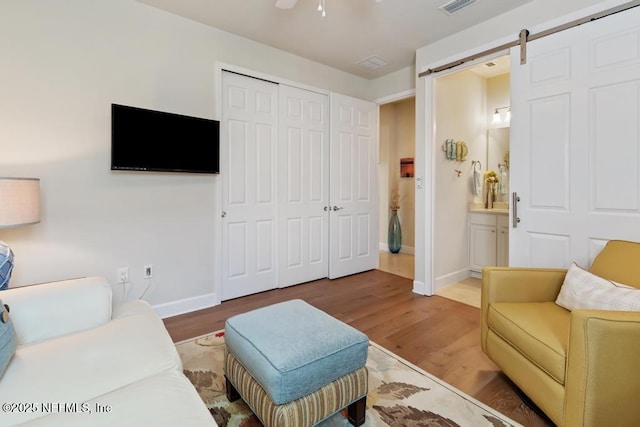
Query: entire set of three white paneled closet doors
220 71 378 301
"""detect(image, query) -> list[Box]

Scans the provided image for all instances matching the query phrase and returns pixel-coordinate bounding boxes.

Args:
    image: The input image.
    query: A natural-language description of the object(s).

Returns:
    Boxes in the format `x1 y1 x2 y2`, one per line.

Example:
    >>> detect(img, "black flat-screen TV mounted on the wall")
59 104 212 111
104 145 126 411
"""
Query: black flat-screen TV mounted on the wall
111 104 220 174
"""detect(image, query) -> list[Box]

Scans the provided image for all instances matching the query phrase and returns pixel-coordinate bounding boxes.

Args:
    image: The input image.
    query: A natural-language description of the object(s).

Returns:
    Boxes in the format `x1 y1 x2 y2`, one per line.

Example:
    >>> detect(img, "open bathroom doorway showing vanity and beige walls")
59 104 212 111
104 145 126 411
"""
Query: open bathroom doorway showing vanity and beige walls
432 55 510 306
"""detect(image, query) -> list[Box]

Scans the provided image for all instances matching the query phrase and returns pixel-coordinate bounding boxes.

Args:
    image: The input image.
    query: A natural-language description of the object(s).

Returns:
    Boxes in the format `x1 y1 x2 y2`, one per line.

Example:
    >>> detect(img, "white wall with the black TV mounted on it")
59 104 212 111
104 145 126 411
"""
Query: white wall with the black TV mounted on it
0 0 376 313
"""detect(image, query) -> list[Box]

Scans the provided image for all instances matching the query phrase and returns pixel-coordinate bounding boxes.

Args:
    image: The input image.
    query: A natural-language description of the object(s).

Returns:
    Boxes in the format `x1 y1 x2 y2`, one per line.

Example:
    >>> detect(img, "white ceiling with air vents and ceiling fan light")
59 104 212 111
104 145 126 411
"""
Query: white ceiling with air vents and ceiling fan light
139 0 532 79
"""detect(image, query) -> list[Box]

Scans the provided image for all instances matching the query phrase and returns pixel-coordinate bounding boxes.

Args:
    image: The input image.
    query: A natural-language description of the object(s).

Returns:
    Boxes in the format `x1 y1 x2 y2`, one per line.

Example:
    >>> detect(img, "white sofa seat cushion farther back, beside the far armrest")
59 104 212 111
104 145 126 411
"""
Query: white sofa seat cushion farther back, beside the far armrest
0 301 182 426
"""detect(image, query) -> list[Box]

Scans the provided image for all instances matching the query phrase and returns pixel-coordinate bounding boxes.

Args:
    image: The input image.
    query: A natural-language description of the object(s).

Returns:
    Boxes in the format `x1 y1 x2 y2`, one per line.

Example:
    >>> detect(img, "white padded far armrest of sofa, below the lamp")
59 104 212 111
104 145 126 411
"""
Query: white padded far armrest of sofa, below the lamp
2 277 112 344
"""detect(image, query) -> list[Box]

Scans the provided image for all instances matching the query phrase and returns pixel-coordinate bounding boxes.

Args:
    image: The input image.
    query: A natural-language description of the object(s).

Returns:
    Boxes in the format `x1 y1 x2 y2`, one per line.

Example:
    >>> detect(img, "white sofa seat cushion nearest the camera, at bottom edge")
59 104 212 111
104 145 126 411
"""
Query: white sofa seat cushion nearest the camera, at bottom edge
16 371 216 427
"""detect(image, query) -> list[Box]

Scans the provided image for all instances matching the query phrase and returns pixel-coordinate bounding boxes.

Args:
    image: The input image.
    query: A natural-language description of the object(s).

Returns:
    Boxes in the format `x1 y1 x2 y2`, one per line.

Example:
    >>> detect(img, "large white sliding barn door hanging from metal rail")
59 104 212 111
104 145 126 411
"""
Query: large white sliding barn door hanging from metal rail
509 8 640 268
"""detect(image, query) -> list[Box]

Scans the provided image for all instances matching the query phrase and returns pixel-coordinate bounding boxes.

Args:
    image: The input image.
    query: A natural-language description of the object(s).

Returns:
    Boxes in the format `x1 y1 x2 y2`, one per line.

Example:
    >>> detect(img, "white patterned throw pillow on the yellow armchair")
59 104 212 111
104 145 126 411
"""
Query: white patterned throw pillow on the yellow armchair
556 262 640 311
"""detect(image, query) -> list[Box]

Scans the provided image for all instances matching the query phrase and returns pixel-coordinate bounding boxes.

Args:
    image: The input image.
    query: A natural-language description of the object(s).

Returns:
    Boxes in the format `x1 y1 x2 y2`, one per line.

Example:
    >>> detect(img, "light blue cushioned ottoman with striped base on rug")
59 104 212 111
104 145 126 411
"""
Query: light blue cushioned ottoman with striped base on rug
225 300 369 427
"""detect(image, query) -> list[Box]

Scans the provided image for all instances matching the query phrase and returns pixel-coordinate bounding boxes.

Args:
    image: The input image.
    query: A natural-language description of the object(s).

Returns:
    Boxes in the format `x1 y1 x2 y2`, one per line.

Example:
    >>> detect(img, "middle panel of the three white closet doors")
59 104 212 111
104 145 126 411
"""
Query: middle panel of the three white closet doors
278 84 329 287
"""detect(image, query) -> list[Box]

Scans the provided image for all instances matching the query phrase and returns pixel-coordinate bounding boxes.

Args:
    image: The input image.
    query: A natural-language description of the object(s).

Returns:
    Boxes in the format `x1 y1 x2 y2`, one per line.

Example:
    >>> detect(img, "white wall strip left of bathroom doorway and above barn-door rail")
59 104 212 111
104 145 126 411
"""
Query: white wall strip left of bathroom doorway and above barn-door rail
414 0 625 294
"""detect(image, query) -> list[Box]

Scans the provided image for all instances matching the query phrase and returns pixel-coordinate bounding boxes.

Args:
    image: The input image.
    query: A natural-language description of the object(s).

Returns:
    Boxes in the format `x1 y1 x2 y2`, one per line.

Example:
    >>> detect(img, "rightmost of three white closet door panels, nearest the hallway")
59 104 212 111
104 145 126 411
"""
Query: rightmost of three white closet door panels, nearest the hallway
329 94 378 279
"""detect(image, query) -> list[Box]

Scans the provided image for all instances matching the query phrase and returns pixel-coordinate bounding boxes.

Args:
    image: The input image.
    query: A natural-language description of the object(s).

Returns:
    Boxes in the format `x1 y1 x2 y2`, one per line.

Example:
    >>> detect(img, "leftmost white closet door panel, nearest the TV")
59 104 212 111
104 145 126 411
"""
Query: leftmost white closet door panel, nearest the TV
220 71 278 301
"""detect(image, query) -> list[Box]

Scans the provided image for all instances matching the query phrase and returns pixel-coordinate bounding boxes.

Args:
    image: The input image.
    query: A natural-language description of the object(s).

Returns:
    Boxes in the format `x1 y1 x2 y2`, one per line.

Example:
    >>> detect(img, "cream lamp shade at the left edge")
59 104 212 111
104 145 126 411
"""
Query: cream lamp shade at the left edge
0 178 40 228
